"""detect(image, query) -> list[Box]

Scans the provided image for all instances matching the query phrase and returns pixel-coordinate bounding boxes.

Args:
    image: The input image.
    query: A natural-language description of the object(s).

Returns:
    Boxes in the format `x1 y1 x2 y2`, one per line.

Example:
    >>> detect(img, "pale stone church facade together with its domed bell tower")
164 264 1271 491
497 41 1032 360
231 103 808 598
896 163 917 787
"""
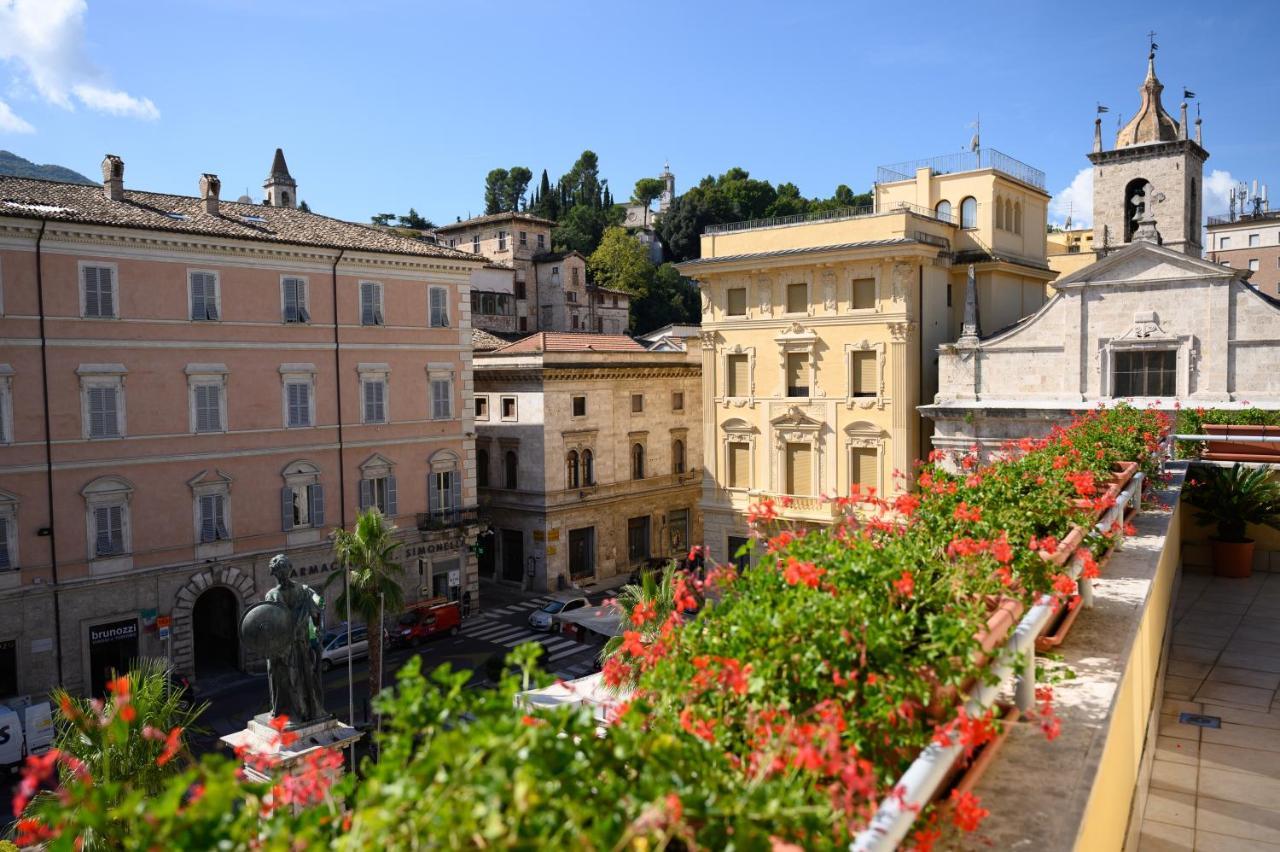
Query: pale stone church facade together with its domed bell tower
920 48 1280 455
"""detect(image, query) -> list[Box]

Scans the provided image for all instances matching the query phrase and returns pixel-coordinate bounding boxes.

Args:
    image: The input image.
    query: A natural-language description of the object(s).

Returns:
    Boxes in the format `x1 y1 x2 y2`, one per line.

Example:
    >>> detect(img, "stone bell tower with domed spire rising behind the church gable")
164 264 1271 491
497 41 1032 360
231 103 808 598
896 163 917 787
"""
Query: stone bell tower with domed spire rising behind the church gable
1089 41 1208 257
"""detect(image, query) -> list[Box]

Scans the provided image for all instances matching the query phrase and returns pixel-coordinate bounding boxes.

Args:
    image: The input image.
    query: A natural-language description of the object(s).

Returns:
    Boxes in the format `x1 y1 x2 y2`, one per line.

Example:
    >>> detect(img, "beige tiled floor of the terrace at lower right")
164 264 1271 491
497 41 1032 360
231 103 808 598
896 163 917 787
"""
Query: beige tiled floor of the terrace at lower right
1138 571 1280 852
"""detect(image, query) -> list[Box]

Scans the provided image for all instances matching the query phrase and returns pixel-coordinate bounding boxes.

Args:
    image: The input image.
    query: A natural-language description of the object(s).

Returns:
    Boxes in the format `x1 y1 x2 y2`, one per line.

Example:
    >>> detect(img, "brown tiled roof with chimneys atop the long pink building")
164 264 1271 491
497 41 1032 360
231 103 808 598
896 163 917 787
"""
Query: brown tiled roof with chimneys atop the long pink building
0 175 485 262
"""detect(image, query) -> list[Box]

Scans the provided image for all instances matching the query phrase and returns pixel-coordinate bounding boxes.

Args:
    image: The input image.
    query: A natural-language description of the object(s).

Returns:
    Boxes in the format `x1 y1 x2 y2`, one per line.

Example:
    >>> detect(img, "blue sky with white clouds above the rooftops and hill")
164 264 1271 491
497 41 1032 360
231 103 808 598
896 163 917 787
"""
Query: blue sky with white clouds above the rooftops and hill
0 0 1280 223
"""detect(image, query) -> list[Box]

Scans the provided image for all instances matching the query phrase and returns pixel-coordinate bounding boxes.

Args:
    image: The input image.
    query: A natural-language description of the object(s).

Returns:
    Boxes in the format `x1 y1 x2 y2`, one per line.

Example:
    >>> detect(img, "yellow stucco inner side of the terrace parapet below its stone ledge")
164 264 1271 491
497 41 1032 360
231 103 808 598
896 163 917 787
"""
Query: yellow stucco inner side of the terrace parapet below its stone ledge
1075 501 1183 852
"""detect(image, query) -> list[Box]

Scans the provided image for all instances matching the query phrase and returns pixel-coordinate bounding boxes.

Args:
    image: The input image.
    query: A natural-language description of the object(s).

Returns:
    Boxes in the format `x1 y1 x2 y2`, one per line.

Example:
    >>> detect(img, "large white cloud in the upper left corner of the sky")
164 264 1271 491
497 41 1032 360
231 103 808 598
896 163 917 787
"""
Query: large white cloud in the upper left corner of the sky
0 0 160 129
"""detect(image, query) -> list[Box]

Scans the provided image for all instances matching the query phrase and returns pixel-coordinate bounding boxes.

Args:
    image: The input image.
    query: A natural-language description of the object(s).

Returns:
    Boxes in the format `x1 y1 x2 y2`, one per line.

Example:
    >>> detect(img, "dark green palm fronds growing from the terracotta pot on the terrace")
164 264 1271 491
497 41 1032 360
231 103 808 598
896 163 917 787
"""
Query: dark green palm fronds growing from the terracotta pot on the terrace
1187 462 1280 541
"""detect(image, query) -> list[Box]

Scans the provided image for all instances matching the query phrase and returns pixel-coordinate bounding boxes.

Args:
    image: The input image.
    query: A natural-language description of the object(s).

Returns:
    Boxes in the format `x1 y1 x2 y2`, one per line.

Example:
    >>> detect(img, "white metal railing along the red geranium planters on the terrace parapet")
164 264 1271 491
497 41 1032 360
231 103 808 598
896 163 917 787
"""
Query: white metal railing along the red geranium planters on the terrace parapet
849 472 1144 852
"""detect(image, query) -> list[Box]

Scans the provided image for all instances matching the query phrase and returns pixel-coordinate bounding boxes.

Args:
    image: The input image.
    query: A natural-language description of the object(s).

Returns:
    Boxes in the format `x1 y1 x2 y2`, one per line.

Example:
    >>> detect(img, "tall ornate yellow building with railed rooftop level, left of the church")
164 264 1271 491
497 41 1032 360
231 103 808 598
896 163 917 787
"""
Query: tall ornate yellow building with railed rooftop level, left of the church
680 150 1053 559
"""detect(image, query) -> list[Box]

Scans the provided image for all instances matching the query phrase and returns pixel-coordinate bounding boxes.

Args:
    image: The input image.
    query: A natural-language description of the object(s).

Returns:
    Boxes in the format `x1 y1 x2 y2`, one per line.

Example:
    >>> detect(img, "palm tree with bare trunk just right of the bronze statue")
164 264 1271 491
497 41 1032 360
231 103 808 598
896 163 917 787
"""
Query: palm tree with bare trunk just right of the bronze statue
325 507 404 698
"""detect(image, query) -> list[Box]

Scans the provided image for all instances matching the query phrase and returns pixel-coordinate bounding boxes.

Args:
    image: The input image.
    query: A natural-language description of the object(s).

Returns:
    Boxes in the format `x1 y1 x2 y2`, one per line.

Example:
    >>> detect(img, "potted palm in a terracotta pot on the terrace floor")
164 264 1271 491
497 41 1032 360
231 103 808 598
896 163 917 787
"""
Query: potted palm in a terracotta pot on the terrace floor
1187 462 1280 577
